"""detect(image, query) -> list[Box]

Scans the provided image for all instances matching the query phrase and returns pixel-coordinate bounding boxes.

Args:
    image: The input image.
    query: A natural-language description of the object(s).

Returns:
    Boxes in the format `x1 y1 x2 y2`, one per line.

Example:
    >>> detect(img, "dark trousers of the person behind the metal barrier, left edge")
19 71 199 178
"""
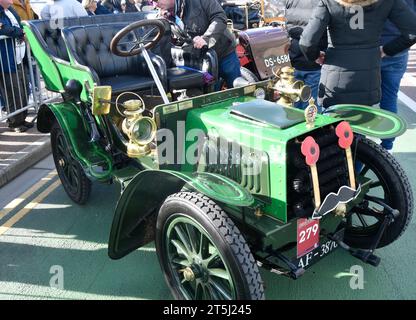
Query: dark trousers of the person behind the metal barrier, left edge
0 70 27 128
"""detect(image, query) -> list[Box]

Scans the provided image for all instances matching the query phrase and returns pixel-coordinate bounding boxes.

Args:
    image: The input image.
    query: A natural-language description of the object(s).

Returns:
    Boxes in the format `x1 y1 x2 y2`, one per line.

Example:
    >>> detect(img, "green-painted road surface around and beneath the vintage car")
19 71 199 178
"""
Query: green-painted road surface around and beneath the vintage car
0 100 416 300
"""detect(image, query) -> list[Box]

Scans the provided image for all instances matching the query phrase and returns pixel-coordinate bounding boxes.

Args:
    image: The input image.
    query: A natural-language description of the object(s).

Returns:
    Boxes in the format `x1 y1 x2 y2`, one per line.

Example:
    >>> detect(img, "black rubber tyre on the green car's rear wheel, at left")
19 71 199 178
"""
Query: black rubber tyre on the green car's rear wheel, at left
51 121 91 205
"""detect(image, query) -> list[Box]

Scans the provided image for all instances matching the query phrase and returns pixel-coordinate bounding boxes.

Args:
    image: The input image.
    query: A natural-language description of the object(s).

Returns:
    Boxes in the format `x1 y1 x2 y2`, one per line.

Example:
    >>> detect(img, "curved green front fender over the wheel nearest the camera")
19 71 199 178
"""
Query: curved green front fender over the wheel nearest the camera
108 170 254 259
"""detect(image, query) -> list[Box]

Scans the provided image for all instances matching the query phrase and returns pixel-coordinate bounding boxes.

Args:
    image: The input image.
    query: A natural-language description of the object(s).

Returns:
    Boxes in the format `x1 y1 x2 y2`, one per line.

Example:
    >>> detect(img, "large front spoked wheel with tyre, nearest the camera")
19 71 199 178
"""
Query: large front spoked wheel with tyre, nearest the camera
156 192 264 300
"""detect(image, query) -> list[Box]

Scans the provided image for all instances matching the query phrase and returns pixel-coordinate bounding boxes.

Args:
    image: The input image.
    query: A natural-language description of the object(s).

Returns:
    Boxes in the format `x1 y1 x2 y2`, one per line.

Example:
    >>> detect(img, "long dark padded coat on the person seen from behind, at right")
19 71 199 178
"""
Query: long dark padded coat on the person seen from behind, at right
300 0 416 108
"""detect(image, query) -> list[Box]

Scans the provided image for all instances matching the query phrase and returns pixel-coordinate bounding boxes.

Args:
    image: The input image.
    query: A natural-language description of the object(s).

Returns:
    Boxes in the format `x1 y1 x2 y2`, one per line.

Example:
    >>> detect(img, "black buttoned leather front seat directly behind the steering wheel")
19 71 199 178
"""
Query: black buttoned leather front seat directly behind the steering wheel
62 23 161 93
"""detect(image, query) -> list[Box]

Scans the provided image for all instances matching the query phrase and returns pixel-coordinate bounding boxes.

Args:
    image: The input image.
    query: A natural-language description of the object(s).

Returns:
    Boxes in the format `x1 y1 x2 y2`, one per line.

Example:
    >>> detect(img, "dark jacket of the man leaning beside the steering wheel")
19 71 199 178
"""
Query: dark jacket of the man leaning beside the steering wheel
177 0 237 60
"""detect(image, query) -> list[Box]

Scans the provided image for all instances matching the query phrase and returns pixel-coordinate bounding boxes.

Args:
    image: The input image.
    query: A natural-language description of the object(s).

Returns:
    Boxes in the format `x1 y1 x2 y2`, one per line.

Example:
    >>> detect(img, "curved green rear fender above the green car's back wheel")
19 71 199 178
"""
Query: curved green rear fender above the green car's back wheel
38 102 113 181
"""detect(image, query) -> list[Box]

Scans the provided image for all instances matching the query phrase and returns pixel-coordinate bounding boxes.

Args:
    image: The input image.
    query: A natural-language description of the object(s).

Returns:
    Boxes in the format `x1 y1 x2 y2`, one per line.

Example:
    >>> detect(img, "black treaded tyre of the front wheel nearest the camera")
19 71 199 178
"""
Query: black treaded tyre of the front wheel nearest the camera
156 192 265 300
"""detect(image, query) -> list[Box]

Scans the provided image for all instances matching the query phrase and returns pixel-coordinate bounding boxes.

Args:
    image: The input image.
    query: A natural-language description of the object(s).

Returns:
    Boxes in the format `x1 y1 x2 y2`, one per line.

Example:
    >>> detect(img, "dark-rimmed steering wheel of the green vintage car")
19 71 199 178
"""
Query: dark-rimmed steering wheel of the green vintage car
110 19 166 57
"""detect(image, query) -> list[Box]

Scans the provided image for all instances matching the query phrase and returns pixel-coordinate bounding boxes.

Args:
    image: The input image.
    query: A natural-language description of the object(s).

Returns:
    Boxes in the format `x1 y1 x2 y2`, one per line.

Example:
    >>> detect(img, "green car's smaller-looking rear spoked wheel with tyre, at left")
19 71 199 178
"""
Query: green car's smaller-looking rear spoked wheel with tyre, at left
51 122 91 204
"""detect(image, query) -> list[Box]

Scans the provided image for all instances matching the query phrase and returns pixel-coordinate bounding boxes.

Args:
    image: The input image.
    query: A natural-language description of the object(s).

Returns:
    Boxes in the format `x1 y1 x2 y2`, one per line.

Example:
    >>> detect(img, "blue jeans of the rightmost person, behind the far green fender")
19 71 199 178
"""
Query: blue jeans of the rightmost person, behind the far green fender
380 53 409 150
